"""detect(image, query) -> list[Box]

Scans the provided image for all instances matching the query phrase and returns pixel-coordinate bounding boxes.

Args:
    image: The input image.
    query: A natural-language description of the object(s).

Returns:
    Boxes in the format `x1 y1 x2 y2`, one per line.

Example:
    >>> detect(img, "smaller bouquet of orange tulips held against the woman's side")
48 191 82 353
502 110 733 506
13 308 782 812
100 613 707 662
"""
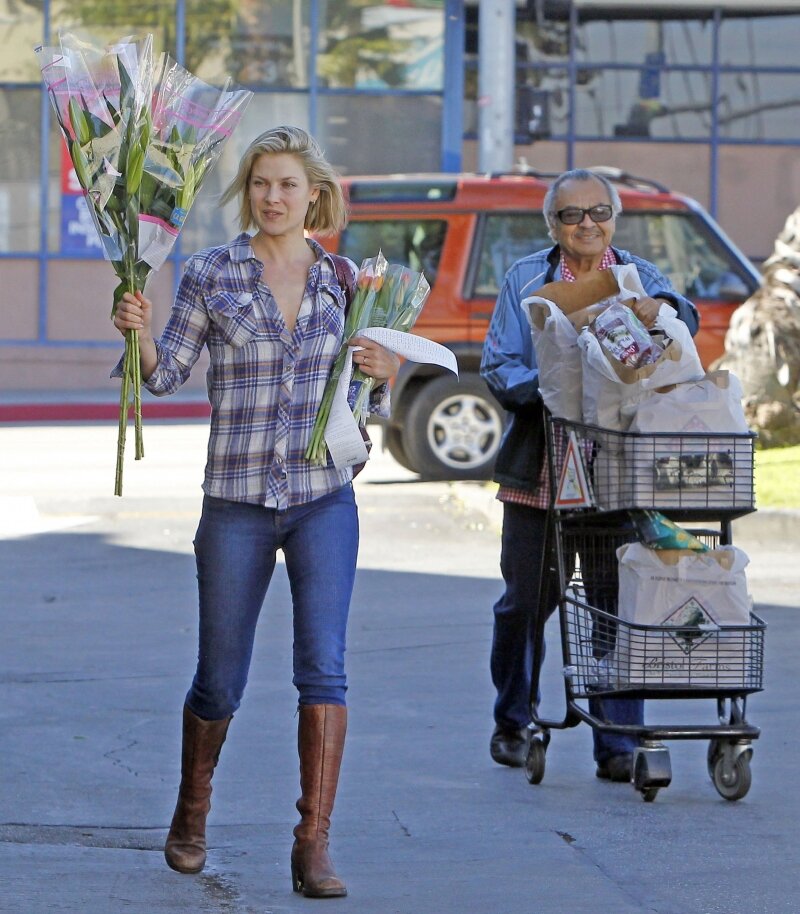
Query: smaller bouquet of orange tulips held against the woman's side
305 252 430 466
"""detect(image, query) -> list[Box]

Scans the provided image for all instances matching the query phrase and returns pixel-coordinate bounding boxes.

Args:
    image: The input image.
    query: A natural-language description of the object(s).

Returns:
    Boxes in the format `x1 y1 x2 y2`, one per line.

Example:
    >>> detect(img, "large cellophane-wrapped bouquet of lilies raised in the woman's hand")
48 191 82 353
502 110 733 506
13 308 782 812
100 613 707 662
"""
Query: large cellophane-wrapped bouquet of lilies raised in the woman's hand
36 34 253 495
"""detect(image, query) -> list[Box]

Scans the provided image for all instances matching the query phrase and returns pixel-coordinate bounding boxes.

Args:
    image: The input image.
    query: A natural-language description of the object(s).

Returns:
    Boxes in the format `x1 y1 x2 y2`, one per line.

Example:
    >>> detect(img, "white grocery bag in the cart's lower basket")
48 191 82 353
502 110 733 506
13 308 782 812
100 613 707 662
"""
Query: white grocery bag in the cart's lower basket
615 543 761 688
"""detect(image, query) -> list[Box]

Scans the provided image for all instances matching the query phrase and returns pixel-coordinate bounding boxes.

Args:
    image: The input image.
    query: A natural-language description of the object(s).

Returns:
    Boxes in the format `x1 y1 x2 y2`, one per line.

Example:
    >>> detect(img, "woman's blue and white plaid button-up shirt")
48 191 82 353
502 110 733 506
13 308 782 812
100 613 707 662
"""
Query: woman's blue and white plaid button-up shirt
145 234 389 510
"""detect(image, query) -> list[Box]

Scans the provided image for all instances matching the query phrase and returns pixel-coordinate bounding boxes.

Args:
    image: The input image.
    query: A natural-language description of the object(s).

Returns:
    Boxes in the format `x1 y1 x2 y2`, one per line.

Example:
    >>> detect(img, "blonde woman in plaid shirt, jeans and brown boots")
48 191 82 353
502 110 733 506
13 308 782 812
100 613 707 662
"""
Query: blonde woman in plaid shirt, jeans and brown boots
115 127 398 897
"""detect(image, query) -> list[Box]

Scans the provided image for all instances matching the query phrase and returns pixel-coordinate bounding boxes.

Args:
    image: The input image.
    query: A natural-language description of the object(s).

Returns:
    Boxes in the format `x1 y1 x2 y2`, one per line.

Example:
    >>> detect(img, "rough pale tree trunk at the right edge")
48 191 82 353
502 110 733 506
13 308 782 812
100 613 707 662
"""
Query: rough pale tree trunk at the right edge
715 207 800 447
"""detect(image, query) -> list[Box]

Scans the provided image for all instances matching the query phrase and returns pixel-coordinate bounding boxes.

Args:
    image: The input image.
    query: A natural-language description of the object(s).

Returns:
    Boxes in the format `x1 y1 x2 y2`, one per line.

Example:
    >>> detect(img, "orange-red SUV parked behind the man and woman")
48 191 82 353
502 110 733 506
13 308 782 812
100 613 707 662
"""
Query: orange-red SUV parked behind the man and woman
324 168 759 479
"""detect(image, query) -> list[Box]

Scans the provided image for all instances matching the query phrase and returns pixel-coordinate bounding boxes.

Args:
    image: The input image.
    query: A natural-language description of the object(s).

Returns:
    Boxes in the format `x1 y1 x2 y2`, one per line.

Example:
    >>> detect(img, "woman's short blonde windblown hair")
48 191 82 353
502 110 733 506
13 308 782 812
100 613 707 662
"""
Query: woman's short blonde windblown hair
220 126 347 235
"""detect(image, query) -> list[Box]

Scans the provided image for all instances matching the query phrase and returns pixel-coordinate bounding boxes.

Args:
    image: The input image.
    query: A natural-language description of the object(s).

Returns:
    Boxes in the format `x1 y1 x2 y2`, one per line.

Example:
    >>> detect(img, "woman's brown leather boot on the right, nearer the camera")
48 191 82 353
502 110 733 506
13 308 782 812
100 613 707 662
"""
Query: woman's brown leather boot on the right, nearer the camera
292 705 347 898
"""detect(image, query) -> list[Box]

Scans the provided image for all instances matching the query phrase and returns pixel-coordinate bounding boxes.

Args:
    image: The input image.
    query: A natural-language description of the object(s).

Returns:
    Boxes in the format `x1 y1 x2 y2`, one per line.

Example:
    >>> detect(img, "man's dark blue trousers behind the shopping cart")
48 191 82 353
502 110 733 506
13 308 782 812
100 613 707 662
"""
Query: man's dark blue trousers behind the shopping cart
490 502 644 762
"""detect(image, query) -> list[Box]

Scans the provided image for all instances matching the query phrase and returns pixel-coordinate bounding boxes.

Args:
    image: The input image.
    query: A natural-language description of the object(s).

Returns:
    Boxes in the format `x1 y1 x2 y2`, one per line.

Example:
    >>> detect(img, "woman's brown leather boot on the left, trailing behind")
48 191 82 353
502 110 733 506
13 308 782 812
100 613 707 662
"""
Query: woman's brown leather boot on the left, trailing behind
164 705 232 873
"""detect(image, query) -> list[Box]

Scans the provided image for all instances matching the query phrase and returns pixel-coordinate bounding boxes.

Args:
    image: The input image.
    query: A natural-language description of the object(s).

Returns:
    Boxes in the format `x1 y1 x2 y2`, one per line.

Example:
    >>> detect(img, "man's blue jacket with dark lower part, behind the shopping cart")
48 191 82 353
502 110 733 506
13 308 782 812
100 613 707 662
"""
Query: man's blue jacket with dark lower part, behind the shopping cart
481 245 699 491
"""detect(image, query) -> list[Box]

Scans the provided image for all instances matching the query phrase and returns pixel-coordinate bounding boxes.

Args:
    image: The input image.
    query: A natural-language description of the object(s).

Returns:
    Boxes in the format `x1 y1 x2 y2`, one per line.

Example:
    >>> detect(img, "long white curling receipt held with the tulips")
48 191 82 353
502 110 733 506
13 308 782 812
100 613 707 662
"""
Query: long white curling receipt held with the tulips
325 327 458 470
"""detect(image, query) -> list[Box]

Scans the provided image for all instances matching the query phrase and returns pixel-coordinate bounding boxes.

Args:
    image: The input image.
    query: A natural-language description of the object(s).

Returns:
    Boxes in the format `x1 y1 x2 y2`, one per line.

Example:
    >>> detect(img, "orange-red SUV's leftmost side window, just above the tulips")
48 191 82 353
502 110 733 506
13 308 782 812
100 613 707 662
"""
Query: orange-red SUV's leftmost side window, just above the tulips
339 219 447 288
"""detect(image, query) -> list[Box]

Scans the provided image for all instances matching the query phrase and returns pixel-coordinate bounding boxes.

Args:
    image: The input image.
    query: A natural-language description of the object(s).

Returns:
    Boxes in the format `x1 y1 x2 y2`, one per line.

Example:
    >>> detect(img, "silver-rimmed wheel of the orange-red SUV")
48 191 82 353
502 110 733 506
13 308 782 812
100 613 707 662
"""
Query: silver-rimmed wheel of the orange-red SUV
404 372 503 479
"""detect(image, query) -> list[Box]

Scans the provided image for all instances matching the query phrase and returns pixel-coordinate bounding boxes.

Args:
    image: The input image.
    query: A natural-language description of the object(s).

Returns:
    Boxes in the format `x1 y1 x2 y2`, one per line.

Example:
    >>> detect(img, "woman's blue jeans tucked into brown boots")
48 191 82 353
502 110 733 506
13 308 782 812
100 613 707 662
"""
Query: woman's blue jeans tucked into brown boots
186 485 358 720
